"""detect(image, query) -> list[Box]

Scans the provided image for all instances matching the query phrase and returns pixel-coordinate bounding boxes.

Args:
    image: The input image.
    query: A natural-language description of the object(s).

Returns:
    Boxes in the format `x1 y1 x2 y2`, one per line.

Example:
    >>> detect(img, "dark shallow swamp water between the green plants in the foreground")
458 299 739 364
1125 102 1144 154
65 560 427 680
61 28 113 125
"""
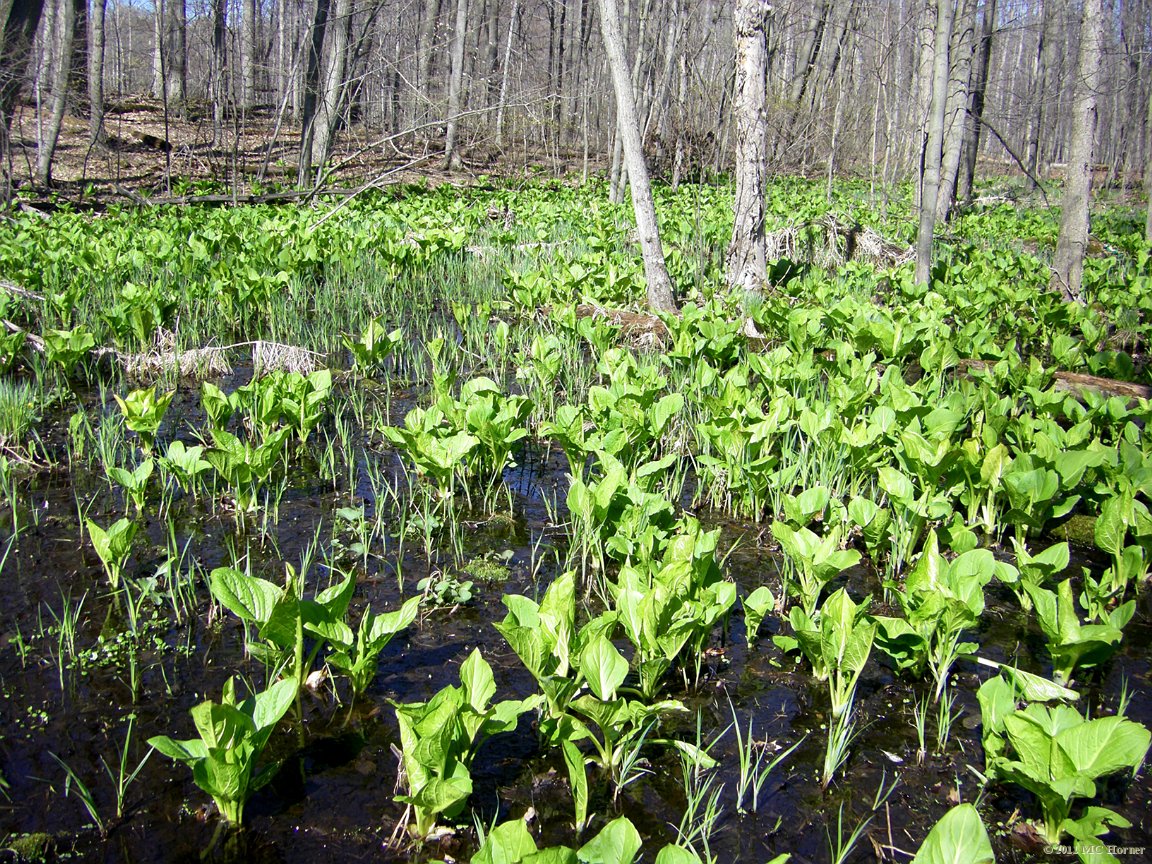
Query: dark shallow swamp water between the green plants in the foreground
0 370 1152 864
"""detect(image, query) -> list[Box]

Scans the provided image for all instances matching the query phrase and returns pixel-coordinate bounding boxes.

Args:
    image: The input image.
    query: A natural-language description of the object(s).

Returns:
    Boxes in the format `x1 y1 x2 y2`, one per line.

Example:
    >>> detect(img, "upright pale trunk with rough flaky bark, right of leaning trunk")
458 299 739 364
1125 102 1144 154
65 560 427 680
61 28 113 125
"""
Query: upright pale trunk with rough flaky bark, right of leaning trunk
727 0 772 293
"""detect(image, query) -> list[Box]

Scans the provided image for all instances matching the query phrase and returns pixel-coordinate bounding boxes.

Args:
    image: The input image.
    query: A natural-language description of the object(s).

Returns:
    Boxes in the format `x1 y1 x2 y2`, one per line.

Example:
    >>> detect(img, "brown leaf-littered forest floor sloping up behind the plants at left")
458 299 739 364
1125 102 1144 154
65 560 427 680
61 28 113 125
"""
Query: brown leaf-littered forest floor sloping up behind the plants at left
4 98 589 206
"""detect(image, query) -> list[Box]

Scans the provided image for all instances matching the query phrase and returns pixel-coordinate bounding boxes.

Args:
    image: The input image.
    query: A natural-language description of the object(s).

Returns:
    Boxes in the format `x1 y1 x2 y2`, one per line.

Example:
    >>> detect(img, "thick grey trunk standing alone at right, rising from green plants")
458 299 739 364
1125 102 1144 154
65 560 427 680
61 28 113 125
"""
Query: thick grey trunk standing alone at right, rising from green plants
1051 0 1102 303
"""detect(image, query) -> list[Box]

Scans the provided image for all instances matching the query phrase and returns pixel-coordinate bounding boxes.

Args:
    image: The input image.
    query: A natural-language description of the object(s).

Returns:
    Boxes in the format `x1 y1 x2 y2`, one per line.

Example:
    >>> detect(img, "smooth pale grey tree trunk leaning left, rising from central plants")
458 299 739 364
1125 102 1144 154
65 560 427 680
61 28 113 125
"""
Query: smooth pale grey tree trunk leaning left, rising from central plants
597 0 676 312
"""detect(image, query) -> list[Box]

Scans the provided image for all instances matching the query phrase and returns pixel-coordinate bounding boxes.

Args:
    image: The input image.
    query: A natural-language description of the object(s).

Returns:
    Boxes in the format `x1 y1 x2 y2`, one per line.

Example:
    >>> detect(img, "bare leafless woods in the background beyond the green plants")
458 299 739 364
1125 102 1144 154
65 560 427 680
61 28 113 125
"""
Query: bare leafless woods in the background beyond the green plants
0 0 1152 198
